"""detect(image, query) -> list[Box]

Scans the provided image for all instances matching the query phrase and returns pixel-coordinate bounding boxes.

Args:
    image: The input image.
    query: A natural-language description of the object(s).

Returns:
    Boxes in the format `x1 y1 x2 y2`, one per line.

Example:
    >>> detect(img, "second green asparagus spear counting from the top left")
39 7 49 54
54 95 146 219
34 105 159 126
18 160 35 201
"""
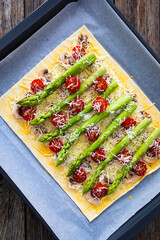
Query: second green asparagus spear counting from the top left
29 66 107 125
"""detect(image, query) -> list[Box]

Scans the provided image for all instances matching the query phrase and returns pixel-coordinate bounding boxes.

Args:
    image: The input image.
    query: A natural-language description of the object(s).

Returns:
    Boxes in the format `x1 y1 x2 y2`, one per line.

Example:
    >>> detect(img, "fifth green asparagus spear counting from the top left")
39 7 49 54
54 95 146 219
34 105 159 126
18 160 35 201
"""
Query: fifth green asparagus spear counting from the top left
67 102 136 177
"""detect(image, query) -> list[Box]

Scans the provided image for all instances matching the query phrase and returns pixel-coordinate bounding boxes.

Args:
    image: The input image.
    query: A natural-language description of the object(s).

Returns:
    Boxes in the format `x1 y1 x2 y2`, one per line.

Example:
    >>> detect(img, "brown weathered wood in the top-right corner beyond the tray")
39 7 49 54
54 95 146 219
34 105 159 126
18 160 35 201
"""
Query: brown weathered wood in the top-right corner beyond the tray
114 0 160 55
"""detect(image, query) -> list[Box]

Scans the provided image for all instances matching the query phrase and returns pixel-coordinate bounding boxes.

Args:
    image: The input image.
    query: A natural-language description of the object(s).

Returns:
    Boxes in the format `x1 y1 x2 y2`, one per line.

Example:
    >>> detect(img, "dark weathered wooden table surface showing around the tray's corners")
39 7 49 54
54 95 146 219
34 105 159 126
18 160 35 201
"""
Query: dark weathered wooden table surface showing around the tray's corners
0 0 160 240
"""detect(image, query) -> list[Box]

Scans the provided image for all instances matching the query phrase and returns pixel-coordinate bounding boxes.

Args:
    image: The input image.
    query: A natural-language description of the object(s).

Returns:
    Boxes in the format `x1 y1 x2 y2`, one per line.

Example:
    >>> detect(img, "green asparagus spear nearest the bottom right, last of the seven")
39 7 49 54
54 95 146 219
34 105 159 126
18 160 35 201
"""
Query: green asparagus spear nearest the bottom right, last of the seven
107 128 160 195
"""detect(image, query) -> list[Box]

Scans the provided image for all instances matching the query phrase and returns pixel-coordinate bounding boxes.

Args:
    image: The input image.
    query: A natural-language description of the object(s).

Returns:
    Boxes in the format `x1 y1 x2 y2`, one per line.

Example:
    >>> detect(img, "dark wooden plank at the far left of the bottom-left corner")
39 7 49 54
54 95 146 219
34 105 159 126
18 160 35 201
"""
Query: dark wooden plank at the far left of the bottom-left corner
0 174 25 240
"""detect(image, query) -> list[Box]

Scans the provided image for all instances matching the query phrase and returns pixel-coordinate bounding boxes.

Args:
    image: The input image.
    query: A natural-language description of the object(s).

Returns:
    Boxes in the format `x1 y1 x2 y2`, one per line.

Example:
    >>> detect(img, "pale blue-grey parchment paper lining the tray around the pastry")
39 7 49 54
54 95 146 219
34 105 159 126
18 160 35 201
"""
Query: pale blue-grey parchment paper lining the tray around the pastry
0 0 160 240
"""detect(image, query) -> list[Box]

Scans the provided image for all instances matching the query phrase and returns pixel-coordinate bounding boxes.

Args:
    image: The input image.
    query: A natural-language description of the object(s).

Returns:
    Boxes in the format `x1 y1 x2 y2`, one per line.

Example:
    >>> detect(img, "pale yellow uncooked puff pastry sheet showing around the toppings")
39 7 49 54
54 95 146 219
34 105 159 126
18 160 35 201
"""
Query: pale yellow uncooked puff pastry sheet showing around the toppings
0 26 160 221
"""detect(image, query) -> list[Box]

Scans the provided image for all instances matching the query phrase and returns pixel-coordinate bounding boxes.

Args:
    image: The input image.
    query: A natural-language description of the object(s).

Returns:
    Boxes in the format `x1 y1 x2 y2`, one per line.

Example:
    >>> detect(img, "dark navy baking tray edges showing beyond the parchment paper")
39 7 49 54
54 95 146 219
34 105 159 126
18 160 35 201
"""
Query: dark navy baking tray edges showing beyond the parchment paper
0 0 160 240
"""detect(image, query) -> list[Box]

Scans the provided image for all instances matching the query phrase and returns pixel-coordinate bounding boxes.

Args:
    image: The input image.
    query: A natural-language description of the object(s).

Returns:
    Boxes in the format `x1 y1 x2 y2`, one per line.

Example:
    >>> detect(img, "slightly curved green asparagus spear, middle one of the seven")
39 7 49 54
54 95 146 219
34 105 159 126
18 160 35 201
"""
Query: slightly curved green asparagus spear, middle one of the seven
56 94 133 166
